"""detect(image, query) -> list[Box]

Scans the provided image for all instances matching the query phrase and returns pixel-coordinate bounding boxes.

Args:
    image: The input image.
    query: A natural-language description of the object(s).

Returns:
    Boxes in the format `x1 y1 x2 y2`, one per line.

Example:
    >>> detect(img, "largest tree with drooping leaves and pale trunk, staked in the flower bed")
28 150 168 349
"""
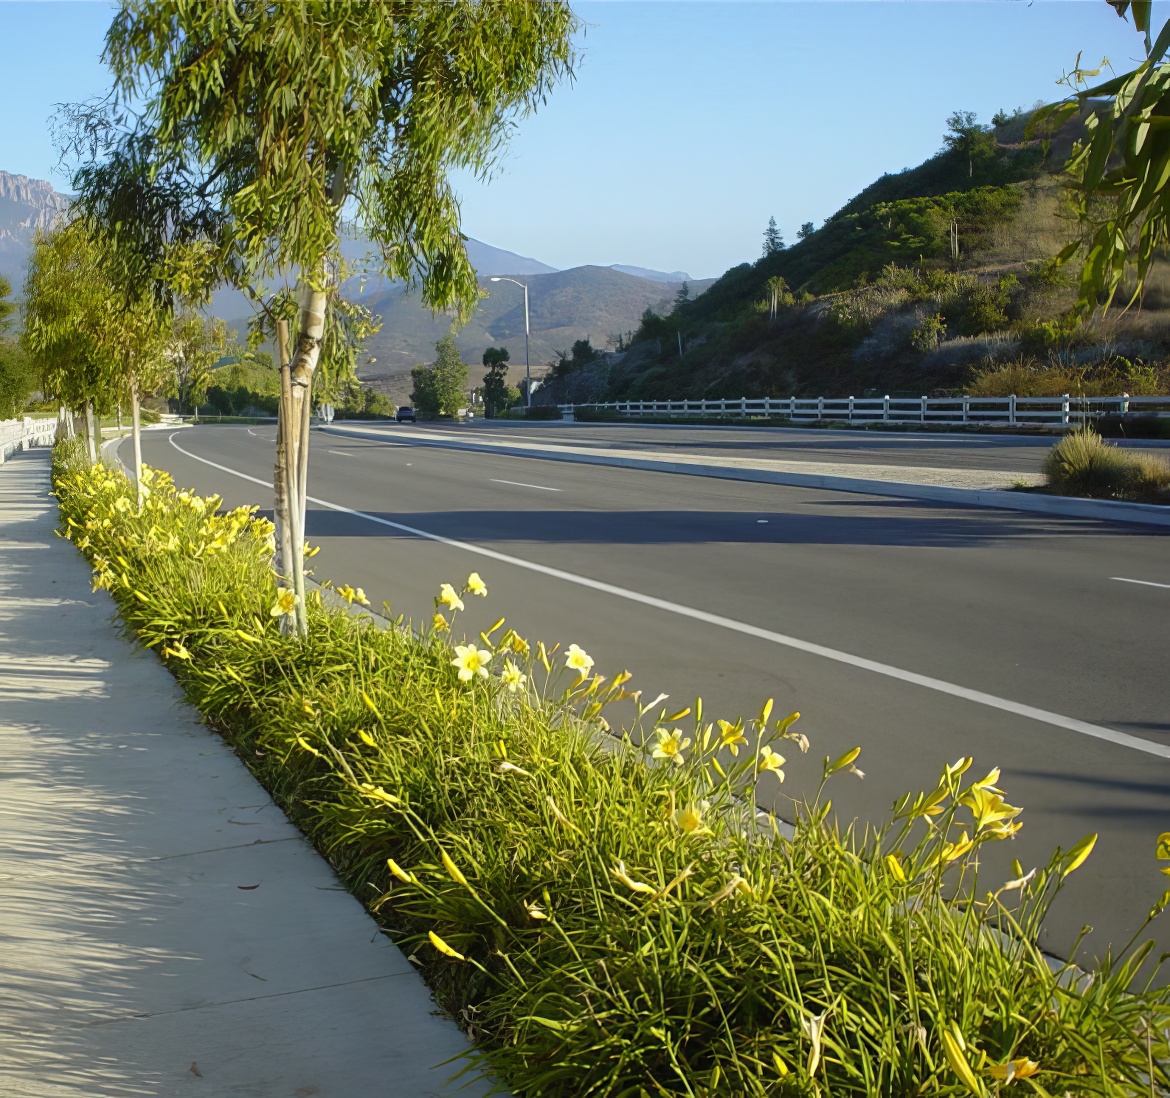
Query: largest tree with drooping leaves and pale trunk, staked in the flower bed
76 0 577 625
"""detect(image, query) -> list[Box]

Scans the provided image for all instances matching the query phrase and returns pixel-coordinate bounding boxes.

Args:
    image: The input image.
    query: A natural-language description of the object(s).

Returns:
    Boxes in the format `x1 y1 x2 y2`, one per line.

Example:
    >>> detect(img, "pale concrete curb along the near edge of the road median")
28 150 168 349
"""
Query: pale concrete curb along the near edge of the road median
321 425 1170 527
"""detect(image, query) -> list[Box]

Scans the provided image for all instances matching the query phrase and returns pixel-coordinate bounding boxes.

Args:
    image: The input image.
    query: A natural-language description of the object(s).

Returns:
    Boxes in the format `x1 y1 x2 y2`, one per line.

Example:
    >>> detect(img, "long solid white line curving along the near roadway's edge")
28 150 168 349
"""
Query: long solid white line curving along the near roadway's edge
171 434 1170 759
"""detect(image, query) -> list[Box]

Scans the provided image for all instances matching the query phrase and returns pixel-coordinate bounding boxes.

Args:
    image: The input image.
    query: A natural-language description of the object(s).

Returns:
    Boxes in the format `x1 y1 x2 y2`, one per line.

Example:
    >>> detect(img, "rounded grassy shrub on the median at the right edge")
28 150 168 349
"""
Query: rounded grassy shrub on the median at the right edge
1044 428 1170 502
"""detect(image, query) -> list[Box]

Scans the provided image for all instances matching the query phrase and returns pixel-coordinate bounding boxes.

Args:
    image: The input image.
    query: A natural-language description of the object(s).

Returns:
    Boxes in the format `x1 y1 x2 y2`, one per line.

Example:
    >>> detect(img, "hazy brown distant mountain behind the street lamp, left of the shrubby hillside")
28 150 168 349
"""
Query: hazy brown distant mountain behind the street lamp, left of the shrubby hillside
359 267 714 400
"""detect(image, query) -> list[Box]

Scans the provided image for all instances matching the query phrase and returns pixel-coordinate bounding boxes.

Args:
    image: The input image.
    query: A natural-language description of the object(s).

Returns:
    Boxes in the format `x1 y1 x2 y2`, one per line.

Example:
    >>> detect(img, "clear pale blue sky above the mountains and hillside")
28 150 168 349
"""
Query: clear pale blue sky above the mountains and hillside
0 0 1170 277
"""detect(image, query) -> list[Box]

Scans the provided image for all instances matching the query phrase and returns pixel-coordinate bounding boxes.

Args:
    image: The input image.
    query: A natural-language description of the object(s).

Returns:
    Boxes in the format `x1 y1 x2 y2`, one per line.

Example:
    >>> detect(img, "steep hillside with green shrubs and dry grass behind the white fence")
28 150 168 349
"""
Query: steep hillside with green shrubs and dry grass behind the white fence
539 112 1170 403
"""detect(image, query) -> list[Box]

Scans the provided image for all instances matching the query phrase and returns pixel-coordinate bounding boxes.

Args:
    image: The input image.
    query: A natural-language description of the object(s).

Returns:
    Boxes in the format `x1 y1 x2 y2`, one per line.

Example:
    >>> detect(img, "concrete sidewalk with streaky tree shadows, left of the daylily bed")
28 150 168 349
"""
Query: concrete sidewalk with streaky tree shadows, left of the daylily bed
0 450 489 1098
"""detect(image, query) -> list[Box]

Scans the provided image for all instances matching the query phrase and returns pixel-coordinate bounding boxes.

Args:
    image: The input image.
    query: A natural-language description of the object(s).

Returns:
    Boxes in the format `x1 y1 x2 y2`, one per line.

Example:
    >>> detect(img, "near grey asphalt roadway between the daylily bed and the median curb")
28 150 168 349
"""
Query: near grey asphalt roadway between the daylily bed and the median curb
128 426 1170 953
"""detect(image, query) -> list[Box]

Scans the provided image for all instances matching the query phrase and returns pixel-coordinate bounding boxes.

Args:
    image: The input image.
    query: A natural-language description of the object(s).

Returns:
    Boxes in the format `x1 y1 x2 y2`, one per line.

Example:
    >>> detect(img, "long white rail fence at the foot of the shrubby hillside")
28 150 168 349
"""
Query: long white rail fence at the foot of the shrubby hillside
559 393 1170 425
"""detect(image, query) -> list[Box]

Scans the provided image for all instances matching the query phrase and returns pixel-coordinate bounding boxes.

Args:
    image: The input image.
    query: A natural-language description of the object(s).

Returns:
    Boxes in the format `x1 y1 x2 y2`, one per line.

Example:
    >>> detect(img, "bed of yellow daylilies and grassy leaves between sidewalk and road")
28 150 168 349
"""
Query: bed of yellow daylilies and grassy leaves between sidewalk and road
54 444 1170 1098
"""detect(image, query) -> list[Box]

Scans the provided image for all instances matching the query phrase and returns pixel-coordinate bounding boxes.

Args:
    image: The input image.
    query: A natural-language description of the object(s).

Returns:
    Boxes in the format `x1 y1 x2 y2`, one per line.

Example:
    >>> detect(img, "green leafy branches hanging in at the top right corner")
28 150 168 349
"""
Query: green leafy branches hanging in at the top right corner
1030 0 1170 314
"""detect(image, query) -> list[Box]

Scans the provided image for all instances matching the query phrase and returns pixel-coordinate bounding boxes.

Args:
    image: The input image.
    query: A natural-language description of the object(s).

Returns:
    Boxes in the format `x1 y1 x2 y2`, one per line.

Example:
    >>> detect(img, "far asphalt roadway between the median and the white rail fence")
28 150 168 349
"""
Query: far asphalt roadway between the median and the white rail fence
404 420 1170 473
